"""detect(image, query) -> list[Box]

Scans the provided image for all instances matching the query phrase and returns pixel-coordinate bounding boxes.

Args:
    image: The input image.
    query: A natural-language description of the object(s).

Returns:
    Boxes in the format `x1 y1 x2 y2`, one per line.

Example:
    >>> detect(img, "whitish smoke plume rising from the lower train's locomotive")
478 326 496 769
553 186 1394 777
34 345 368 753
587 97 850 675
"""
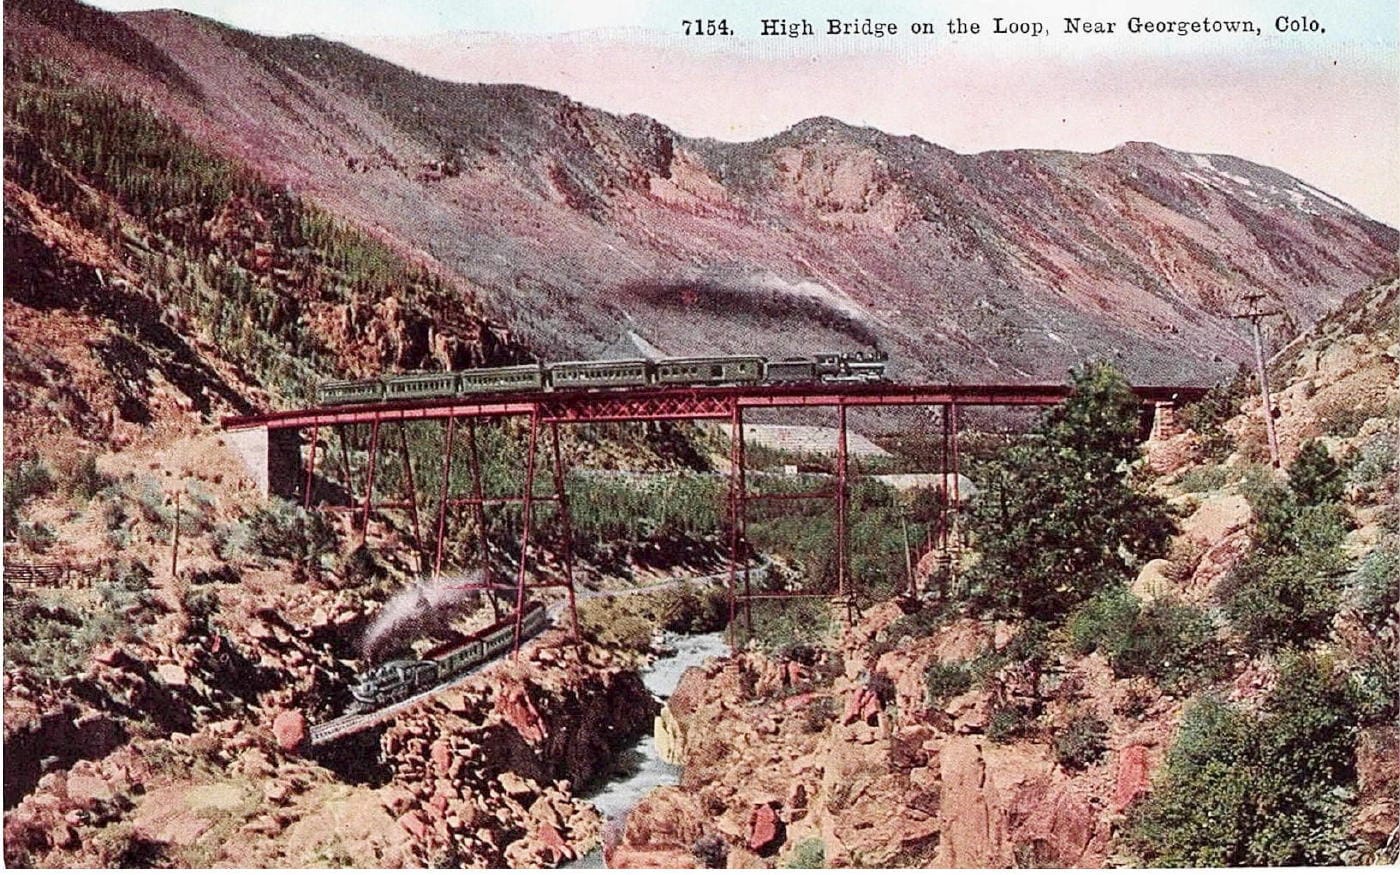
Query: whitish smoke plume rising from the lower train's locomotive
360 568 515 662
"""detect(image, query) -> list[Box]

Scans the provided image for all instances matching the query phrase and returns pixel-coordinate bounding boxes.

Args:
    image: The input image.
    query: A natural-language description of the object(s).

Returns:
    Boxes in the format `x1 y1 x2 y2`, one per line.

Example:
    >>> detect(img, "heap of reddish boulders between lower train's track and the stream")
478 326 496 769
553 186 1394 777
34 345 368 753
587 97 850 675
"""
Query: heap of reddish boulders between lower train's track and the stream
379 634 655 868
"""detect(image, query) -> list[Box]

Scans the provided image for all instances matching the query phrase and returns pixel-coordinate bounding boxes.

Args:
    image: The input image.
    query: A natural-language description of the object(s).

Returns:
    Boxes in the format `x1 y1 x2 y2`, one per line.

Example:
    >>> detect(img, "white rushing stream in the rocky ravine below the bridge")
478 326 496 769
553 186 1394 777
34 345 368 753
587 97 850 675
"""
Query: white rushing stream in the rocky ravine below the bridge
564 631 728 869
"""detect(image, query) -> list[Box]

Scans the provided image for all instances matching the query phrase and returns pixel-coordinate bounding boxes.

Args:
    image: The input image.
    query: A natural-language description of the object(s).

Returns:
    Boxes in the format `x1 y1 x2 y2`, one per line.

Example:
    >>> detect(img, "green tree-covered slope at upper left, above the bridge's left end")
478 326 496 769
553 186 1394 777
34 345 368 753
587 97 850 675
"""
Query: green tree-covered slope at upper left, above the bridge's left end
4 57 518 402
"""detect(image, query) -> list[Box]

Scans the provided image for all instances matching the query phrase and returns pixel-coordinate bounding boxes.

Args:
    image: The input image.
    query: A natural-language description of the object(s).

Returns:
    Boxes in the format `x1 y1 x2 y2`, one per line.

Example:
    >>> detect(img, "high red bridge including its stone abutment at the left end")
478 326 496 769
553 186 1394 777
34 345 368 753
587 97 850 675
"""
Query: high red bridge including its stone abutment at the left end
223 382 1205 649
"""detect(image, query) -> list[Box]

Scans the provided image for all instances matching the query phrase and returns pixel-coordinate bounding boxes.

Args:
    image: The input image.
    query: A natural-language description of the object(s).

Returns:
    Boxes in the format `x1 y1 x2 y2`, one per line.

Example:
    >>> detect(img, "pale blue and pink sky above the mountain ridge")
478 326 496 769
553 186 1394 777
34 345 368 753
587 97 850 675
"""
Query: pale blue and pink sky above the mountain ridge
87 0 1400 225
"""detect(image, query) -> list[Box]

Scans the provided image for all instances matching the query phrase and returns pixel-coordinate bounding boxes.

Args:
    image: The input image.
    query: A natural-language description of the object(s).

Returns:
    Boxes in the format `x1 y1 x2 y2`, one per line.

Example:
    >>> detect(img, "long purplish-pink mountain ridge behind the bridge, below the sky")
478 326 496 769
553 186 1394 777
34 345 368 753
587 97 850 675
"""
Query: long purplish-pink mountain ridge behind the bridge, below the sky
4 0 1400 382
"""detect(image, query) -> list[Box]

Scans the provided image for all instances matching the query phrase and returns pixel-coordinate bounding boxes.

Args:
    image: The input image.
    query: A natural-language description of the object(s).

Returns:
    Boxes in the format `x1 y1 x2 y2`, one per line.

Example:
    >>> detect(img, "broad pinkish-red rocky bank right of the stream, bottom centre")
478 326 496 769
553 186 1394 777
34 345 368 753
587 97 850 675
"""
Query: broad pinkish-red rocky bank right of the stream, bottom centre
610 605 1198 868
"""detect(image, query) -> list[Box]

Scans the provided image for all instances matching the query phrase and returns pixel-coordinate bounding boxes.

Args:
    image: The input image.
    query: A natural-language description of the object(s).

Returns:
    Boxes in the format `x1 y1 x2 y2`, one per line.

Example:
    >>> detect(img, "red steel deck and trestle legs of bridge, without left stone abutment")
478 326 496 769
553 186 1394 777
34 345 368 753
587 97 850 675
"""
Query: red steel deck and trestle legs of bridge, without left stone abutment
243 384 1204 652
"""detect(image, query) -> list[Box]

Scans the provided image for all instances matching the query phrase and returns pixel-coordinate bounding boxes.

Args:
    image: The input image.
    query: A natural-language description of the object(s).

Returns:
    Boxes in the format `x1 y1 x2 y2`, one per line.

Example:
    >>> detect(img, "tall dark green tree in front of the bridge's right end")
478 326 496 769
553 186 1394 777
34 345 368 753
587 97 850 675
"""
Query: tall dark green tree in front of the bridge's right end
969 363 1175 619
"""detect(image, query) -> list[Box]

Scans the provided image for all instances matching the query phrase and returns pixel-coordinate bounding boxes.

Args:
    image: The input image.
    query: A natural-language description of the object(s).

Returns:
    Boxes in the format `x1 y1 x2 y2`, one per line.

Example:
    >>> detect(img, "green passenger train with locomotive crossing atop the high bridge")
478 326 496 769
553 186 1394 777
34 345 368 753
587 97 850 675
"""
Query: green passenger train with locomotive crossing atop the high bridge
316 351 888 406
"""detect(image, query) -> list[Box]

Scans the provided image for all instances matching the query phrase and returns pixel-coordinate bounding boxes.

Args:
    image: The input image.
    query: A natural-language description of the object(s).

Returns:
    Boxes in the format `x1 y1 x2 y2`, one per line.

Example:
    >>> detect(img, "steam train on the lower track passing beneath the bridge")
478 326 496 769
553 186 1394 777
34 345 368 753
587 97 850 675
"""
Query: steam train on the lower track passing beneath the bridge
350 602 549 714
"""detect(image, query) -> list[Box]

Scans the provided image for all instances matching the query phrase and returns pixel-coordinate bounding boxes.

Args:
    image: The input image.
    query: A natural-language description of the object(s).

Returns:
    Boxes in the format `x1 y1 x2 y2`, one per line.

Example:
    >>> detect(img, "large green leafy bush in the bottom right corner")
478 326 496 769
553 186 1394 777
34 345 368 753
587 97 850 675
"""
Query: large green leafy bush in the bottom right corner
1127 657 1357 867
